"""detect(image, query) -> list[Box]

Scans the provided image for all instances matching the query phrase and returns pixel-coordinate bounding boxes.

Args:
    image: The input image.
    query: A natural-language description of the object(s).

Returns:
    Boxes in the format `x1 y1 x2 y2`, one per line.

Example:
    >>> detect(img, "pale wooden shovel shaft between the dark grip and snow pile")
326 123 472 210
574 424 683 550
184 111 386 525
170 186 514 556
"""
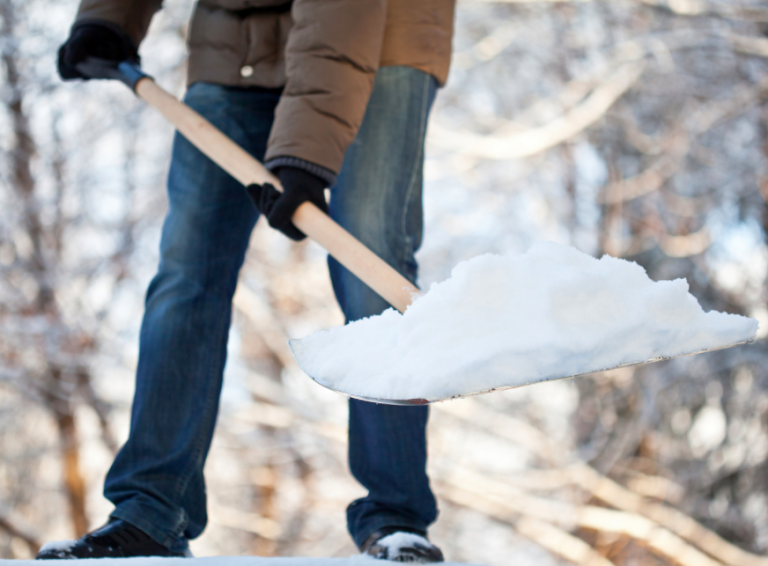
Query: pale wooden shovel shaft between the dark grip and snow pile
136 78 420 312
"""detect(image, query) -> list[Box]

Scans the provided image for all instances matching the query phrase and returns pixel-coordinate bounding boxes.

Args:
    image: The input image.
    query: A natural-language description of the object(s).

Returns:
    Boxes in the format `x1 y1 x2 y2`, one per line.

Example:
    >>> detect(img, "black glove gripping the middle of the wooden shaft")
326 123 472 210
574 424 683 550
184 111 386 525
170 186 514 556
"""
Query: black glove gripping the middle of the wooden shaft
246 167 328 242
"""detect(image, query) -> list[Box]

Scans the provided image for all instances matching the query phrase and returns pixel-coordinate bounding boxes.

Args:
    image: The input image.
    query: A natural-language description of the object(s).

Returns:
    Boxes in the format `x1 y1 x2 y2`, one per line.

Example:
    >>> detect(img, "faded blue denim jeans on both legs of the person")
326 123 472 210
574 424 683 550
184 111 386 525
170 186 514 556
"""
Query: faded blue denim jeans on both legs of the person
104 67 437 550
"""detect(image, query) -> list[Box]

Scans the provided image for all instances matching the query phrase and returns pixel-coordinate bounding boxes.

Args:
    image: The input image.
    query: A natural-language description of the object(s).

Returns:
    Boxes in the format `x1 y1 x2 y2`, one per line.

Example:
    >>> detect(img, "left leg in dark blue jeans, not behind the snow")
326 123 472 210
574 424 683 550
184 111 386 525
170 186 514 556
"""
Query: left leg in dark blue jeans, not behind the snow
104 84 279 548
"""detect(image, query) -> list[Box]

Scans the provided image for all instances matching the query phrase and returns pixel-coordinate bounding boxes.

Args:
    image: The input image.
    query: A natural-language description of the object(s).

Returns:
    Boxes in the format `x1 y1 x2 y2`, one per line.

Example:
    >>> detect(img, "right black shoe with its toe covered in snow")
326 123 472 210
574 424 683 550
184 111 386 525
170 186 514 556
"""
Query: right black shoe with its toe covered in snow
360 527 443 564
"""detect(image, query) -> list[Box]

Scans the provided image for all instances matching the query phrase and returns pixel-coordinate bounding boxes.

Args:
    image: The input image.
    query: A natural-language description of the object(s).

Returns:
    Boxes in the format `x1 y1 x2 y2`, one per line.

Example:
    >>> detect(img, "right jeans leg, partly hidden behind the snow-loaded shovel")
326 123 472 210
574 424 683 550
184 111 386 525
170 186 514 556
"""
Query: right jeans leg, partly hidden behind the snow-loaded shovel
329 67 437 546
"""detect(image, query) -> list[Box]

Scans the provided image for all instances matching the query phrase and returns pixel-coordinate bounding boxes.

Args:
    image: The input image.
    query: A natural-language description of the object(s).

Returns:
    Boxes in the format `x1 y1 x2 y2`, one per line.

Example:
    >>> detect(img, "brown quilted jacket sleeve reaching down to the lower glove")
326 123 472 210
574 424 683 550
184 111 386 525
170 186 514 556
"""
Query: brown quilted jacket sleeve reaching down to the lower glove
266 0 388 178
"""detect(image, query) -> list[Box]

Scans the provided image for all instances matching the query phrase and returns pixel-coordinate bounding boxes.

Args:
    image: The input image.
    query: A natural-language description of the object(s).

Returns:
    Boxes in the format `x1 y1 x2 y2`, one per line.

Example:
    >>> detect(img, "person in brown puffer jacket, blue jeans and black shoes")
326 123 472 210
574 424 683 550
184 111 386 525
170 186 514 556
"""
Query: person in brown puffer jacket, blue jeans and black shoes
38 0 455 563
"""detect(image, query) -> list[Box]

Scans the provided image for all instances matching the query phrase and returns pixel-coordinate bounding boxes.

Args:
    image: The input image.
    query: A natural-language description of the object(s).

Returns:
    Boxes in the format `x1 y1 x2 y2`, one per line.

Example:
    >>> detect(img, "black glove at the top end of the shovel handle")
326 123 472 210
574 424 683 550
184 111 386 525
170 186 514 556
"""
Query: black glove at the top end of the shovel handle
58 23 139 81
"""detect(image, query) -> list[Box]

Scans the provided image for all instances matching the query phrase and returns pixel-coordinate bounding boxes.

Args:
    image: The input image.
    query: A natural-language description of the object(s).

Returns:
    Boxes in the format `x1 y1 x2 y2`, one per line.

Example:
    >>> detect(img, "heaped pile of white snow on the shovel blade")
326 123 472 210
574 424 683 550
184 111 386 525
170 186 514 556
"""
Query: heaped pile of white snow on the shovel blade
292 242 758 400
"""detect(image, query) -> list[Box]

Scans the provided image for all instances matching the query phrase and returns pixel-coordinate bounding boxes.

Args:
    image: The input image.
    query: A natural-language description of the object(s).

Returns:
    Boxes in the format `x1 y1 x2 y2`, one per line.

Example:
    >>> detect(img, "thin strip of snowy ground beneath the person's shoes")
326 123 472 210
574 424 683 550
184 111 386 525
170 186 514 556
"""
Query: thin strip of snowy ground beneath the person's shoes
9 555 480 566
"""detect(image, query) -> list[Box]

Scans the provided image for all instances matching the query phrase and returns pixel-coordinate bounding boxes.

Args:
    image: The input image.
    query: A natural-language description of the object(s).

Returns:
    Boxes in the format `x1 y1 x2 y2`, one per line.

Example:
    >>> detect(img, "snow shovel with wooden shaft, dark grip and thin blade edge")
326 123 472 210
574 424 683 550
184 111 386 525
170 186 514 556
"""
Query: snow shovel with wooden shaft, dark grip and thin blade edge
77 58 752 405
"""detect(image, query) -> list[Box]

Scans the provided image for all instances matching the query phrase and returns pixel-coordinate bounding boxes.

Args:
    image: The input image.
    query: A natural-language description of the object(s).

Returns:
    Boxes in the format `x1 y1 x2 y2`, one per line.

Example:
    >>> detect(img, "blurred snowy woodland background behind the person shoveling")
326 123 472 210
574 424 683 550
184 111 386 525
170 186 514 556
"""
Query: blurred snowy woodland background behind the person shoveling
0 0 768 566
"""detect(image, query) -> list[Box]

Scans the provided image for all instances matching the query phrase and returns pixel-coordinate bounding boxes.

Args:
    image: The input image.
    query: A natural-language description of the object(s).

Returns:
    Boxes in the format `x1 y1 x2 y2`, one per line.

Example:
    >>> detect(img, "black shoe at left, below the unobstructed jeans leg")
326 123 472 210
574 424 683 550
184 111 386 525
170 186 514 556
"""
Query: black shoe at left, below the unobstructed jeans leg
37 519 184 560
